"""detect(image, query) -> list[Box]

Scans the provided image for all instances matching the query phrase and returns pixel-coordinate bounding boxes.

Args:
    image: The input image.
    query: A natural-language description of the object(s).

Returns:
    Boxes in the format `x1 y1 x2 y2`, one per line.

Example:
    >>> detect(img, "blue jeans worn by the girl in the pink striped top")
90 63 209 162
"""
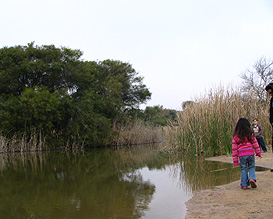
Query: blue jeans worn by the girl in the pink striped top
239 155 256 186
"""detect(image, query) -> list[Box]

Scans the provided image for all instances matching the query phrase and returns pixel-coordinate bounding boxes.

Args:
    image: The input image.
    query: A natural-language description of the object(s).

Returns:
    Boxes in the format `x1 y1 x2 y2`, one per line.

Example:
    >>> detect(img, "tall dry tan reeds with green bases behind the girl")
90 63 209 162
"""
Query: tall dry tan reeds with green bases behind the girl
167 87 271 156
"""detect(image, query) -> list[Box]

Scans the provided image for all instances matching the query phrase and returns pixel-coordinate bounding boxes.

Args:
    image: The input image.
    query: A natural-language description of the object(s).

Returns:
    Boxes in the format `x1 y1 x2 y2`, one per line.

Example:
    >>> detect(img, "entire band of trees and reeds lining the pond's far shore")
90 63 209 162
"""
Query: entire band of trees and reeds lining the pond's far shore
0 42 273 156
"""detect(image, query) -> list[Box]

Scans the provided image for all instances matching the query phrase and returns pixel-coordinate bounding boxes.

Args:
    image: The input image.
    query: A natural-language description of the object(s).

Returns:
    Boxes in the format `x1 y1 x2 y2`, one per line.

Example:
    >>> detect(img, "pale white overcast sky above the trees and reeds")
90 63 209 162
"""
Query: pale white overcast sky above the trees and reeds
0 0 273 110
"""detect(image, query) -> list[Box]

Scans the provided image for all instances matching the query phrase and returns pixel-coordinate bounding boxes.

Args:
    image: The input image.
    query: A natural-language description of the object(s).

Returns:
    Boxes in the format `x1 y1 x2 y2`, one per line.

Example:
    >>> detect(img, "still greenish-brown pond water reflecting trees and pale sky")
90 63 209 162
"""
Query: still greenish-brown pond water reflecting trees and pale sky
0 145 240 219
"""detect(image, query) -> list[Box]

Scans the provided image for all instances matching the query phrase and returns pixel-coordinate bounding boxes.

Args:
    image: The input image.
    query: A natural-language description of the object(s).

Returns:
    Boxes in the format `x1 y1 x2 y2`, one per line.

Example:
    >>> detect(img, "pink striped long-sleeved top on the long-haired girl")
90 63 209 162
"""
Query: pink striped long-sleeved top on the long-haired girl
232 135 262 166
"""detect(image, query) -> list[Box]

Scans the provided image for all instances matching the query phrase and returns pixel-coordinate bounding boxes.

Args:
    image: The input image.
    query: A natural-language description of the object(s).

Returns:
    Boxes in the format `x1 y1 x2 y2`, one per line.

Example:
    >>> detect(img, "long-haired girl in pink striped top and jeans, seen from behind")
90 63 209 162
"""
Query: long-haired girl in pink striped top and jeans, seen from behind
232 118 262 189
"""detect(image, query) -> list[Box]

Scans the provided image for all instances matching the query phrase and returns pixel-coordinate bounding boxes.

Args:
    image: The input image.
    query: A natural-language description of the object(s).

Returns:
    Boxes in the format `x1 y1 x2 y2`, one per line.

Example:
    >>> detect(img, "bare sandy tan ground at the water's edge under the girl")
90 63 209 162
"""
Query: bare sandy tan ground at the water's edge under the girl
186 149 273 219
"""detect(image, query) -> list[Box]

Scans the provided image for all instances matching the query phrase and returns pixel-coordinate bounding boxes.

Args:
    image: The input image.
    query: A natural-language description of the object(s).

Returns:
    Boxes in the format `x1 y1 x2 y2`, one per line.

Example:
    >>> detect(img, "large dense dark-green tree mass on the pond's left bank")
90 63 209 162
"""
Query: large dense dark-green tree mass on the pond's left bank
0 42 151 147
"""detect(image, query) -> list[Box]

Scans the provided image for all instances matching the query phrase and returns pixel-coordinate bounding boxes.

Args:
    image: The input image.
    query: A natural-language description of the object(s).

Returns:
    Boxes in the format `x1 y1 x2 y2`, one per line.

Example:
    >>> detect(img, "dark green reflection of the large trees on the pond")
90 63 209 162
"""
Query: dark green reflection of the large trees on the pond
0 150 155 218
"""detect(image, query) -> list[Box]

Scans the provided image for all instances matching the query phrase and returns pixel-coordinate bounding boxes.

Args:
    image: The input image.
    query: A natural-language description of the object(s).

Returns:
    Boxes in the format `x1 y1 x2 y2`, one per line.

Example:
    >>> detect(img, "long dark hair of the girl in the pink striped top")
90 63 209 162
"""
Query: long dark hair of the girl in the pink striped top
234 118 253 142
